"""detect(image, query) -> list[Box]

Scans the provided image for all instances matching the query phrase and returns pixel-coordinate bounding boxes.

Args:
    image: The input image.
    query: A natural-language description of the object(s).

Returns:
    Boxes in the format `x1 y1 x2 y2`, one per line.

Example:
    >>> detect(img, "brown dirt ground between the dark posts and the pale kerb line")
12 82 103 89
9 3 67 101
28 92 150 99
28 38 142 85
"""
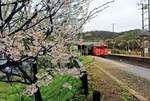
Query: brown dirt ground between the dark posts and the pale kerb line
87 65 137 101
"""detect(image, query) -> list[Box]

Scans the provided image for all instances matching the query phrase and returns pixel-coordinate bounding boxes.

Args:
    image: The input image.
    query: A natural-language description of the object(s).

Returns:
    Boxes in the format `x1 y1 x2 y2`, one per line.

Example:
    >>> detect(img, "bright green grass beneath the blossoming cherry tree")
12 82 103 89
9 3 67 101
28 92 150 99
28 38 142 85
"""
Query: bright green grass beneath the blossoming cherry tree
0 75 81 101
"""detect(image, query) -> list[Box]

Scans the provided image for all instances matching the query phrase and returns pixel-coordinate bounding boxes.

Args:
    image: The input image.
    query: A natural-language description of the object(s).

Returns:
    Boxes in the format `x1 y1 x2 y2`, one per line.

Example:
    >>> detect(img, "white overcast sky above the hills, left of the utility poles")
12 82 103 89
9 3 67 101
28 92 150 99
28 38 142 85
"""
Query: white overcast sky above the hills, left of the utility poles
84 0 141 32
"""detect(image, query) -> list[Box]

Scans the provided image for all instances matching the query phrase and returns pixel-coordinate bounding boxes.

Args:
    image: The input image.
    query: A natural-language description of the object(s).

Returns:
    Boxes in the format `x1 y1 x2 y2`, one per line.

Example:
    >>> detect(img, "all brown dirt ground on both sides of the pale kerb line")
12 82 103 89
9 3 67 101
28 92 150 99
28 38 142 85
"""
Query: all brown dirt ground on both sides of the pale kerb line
86 57 150 101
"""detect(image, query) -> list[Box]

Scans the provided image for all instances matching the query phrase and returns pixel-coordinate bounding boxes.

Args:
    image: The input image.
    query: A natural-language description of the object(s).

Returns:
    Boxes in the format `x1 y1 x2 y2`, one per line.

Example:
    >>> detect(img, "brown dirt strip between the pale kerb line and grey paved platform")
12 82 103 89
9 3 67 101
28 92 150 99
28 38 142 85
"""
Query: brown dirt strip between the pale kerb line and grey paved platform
95 57 150 100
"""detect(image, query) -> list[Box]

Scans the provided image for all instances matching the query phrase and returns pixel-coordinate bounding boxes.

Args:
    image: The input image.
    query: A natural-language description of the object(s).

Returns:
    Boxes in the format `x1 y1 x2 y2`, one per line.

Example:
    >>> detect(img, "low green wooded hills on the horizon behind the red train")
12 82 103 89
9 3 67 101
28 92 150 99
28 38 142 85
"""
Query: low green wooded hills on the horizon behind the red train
81 29 142 41
